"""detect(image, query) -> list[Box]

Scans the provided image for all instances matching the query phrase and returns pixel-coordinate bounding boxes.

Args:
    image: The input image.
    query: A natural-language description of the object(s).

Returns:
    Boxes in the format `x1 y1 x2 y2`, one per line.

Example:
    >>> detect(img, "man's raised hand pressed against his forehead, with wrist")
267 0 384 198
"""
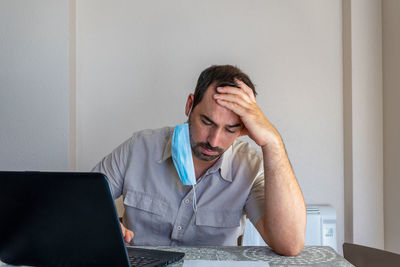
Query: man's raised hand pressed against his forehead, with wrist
214 79 282 150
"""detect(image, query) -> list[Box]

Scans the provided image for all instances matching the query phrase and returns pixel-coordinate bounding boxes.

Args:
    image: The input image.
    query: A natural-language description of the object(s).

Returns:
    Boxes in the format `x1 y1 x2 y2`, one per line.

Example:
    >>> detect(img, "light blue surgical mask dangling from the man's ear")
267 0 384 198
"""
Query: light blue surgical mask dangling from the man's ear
171 123 196 185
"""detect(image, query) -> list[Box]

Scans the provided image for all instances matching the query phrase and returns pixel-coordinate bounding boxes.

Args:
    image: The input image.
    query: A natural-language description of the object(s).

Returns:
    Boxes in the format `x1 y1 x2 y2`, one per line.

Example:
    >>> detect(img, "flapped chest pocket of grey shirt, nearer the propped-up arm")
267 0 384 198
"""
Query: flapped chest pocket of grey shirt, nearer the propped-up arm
195 209 243 246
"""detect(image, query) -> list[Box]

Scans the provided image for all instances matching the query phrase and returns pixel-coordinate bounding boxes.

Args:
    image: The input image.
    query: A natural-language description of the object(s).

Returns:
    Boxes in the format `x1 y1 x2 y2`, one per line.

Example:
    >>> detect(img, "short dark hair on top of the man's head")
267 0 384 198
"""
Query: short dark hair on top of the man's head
192 65 257 110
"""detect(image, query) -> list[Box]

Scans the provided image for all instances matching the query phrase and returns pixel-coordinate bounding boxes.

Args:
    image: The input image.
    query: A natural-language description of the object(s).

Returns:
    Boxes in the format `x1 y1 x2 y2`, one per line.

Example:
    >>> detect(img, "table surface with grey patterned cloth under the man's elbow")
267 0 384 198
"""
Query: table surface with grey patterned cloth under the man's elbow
142 246 353 267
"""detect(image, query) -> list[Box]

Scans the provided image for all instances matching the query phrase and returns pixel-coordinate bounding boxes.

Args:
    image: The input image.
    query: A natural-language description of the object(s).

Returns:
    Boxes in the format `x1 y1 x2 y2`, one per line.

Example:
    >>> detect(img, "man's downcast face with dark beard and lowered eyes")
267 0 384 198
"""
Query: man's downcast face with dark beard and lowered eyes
189 84 243 162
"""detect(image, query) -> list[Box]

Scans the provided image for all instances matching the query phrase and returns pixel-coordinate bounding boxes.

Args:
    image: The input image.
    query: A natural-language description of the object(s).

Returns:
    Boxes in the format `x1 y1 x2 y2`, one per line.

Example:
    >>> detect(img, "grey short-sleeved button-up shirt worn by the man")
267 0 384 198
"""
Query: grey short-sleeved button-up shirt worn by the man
92 127 264 246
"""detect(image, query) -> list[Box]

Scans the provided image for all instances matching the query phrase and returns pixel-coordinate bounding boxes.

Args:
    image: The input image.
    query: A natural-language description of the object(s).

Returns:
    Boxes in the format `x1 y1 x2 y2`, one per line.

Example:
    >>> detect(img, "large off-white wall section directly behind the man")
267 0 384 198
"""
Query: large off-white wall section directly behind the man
76 0 344 251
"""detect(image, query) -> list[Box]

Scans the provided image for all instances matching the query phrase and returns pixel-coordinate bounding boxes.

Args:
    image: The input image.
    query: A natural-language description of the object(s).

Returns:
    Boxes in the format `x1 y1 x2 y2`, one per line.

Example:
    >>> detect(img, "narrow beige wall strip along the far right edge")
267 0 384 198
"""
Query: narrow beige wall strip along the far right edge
382 0 400 253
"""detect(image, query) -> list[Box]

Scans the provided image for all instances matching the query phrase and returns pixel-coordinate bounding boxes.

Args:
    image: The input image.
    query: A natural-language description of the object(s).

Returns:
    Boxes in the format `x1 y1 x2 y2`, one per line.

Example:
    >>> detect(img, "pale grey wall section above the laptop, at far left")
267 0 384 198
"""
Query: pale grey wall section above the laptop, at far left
0 0 69 170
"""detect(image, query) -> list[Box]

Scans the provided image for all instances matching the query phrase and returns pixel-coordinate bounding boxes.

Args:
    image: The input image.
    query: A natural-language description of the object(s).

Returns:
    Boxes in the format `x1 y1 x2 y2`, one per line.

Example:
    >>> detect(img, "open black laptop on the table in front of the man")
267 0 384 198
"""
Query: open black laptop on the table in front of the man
0 172 184 267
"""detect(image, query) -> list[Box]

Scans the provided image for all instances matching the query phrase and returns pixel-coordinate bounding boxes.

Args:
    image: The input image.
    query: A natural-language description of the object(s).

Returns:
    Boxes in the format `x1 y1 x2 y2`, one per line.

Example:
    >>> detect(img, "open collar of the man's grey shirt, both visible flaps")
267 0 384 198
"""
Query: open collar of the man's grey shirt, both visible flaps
157 128 236 182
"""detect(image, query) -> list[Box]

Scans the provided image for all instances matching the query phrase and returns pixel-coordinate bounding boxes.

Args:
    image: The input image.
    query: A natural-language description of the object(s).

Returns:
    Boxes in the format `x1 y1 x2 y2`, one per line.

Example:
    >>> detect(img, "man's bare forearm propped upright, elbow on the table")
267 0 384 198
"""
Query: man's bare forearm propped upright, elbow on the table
262 137 306 255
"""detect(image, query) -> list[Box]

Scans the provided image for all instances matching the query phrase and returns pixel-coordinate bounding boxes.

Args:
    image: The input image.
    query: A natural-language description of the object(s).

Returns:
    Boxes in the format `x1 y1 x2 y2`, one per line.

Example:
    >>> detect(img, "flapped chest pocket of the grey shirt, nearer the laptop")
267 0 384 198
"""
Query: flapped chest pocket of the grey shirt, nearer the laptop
124 190 172 245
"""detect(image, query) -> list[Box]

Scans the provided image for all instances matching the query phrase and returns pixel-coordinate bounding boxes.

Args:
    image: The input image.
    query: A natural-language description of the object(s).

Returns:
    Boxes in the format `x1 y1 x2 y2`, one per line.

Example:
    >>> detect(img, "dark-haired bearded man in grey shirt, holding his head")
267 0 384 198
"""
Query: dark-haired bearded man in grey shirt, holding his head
93 65 306 255
